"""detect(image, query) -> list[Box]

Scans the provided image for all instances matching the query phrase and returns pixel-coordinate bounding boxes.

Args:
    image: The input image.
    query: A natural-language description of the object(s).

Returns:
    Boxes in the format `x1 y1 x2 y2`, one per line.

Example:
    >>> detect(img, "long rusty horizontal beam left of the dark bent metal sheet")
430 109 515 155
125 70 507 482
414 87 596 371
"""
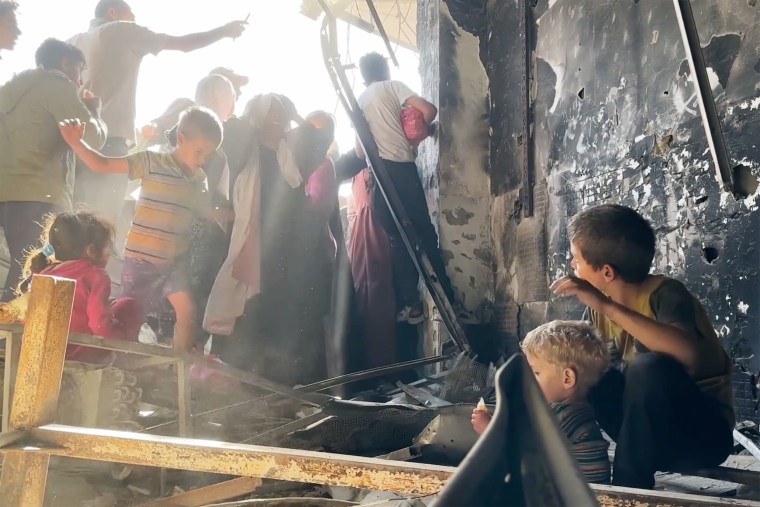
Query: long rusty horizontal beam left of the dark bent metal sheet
31 425 455 495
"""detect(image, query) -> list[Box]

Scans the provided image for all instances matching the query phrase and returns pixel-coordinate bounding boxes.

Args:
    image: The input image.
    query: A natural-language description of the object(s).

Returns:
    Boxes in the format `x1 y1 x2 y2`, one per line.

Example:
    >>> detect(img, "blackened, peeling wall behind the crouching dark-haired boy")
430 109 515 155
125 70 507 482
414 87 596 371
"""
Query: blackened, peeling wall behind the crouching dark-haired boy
423 0 760 419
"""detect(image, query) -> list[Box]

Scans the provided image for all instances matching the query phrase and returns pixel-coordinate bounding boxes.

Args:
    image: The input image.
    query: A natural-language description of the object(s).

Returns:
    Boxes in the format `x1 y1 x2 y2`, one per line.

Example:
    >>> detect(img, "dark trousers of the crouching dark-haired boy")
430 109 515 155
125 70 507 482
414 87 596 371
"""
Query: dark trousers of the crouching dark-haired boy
588 352 733 489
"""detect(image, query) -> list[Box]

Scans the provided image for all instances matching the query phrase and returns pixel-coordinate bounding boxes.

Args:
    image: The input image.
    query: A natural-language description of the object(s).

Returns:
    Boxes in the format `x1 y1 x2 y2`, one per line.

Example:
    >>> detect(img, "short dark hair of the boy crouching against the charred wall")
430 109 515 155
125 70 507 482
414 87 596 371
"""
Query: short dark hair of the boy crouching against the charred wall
569 204 656 283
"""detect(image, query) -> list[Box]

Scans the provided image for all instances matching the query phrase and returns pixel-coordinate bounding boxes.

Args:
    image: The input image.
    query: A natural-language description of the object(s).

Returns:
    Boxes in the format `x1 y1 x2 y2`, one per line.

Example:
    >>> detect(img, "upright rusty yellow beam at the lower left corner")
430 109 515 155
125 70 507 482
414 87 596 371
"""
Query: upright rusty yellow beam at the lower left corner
0 276 76 507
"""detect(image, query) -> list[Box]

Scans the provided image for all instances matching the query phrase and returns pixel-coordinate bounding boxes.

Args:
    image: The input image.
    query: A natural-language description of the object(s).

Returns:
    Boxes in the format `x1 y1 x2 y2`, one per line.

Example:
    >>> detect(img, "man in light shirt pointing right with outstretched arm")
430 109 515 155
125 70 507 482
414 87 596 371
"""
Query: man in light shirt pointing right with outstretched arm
69 0 246 226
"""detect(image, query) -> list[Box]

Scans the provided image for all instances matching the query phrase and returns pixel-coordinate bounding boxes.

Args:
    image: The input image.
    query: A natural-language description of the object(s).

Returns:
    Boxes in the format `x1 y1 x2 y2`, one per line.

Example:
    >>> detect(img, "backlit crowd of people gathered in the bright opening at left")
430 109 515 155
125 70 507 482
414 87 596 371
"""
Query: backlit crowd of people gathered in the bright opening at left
0 0 446 384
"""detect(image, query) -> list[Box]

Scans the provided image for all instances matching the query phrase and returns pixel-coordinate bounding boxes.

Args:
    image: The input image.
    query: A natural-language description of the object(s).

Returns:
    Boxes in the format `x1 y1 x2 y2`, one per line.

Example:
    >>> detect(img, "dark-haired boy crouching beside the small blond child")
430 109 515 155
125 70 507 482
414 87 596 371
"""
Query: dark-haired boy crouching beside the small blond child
552 204 734 488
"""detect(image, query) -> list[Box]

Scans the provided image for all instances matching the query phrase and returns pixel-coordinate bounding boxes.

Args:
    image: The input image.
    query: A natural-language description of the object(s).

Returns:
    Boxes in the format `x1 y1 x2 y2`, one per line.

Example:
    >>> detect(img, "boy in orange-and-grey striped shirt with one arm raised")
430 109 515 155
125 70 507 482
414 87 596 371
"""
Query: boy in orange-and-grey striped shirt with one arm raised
60 107 222 351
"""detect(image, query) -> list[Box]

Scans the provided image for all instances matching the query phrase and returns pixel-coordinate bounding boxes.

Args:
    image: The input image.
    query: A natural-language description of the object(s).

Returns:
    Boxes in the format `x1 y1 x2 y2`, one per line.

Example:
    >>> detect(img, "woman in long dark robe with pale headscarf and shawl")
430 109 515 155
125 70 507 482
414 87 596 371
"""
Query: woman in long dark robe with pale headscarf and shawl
204 94 329 384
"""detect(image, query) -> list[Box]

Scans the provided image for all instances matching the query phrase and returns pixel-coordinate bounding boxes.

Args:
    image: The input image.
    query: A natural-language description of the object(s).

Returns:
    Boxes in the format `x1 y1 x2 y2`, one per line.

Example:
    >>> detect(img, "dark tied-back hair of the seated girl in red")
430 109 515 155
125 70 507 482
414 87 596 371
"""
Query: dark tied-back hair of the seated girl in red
19 210 114 292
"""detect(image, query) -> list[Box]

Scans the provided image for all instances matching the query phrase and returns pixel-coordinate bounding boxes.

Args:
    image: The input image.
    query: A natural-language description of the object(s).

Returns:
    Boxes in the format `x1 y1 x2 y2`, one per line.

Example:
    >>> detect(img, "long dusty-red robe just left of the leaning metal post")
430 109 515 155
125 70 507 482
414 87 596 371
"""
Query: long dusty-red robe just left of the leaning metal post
348 169 397 369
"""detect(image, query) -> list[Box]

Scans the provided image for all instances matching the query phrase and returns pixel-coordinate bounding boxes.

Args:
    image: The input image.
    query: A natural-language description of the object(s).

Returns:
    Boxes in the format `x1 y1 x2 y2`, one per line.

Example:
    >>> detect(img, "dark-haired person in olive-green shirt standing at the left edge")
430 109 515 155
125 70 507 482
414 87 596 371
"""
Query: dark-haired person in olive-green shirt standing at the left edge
0 40 106 301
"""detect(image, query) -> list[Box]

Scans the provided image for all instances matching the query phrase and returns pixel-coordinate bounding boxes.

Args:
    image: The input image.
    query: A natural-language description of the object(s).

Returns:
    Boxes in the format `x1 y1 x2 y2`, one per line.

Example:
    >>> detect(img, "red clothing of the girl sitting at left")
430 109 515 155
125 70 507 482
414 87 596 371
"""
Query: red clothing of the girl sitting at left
42 259 142 362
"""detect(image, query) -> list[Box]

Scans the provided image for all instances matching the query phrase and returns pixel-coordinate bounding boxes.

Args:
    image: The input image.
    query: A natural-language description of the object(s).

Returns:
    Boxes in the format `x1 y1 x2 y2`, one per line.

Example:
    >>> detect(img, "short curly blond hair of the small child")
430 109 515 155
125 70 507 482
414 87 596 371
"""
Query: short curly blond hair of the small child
520 320 610 389
